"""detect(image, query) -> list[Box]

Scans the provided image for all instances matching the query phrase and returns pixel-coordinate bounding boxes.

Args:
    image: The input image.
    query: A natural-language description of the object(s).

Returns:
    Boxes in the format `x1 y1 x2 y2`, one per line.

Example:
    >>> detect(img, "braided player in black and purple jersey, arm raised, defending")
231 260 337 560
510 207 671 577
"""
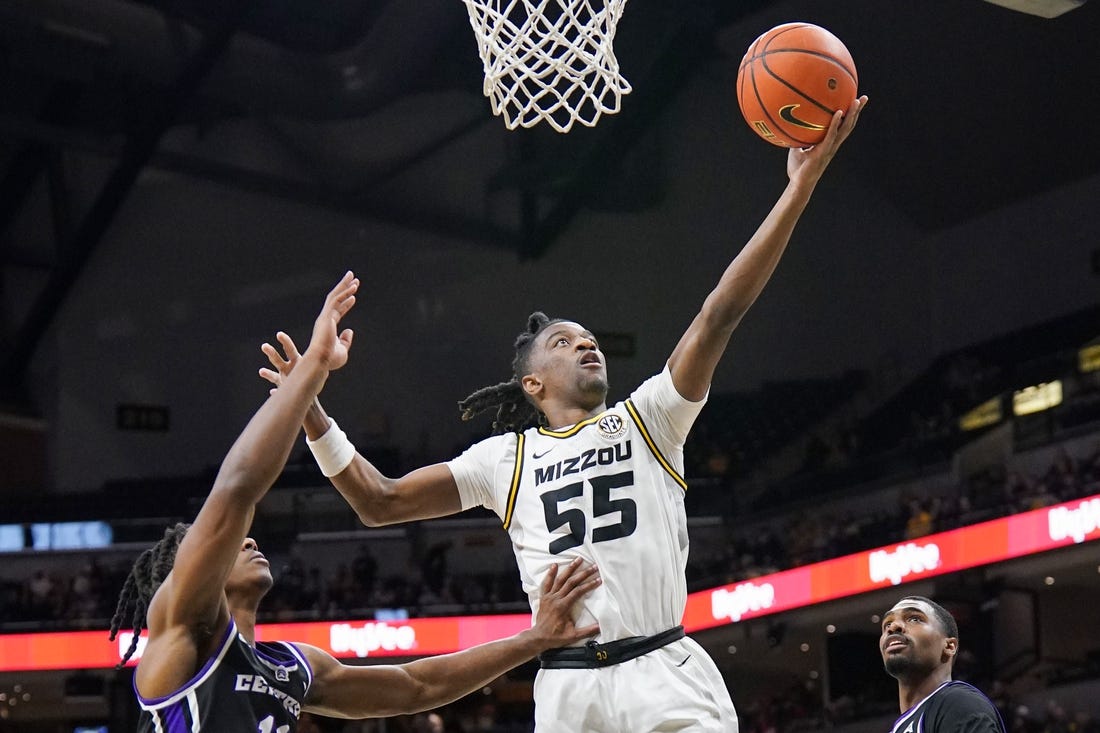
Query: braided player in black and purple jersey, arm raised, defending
111 272 600 733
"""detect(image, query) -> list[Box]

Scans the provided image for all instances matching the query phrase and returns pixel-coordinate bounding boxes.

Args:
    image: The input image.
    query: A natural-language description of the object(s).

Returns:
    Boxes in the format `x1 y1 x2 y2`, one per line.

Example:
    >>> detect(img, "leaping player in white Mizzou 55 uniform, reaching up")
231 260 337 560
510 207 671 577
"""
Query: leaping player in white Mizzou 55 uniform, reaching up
261 97 867 733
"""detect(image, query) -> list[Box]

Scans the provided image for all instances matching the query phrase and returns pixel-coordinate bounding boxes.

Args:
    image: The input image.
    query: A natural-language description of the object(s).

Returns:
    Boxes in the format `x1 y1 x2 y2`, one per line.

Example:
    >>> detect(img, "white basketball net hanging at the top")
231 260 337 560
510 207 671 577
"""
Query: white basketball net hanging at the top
463 0 630 132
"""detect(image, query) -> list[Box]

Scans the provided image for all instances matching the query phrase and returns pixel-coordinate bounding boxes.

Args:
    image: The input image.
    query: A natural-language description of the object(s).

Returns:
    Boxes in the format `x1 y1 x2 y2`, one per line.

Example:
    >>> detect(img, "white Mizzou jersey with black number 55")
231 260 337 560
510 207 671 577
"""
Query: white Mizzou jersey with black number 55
448 367 705 642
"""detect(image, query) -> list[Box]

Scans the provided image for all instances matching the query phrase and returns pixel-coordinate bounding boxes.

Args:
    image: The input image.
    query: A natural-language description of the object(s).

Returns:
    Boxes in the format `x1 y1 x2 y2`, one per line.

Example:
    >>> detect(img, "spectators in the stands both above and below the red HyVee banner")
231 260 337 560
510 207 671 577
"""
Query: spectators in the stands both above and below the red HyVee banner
0 433 1100 733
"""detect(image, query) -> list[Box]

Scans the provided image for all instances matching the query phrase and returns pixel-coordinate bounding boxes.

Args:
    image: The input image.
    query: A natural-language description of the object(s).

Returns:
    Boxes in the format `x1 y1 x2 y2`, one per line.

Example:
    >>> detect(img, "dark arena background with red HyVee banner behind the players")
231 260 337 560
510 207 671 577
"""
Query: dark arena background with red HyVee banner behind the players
0 0 1100 733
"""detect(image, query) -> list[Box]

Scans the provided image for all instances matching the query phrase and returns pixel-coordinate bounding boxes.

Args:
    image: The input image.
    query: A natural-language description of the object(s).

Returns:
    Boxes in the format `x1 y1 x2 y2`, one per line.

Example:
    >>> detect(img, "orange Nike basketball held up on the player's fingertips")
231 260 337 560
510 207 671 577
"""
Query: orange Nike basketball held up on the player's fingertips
737 23 859 147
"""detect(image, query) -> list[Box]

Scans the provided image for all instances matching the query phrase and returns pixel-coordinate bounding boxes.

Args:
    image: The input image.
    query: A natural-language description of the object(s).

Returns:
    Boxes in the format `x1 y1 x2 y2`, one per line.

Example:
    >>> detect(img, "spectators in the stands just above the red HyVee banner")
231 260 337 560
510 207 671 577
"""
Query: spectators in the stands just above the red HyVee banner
0 433 1100 627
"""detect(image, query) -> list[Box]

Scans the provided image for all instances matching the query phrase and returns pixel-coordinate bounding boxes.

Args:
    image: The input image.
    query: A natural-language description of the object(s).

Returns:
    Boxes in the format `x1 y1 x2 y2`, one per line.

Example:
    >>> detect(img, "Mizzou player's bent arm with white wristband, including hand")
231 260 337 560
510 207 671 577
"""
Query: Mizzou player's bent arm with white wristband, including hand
260 331 462 527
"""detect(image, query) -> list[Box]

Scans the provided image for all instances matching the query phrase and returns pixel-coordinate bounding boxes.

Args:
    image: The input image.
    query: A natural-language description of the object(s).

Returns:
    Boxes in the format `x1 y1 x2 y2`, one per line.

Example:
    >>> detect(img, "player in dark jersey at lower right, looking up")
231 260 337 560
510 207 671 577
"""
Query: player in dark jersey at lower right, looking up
879 595 1004 733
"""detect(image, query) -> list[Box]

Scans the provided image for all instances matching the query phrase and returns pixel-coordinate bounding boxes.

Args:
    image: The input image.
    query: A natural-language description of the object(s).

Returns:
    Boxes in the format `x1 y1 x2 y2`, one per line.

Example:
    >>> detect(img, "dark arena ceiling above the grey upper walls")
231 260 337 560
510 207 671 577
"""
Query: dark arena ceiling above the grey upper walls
0 0 1100 402
